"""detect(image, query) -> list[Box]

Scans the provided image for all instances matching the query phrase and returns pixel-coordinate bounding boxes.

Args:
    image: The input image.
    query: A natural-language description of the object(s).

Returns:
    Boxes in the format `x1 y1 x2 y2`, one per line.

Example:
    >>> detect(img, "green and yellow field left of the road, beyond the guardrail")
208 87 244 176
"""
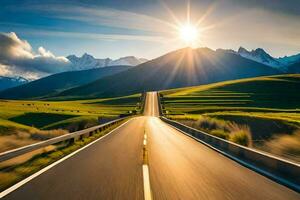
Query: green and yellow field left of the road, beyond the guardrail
0 94 140 151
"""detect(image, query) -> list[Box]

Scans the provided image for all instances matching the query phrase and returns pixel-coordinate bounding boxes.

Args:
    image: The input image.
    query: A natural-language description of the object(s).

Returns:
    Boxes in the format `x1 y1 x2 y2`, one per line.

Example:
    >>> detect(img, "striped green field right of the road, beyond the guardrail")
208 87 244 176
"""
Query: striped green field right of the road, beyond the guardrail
161 74 300 161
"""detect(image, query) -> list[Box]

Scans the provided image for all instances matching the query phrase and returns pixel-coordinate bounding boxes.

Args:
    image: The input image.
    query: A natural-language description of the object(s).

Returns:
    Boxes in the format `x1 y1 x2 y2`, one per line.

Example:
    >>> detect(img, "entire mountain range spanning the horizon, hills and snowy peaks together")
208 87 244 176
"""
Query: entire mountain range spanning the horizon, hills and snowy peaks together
0 47 300 99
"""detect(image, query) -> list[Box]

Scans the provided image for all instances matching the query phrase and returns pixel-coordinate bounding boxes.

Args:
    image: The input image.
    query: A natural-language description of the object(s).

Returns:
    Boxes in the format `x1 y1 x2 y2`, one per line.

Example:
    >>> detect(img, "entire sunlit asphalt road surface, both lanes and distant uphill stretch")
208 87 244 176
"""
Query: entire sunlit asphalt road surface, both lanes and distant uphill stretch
4 93 300 200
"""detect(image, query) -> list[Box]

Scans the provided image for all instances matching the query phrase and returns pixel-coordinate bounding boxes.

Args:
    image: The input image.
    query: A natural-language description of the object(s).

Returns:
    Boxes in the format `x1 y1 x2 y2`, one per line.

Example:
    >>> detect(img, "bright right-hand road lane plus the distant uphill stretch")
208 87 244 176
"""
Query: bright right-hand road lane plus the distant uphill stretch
146 93 300 200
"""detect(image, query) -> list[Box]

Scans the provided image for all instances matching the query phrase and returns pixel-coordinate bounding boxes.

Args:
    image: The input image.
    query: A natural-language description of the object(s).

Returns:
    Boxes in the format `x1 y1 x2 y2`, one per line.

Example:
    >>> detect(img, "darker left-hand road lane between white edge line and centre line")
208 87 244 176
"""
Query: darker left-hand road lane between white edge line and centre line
4 117 146 200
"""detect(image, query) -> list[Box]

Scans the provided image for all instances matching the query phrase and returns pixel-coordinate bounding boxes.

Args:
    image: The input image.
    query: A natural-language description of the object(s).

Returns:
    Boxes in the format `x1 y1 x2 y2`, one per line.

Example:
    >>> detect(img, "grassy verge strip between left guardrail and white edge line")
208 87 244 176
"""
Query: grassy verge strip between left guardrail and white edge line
0 119 128 191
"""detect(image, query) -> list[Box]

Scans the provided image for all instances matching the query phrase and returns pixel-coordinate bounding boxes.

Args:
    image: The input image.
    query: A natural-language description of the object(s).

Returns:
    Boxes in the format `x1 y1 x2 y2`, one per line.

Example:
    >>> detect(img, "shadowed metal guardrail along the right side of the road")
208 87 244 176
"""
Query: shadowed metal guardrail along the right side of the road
160 117 300 192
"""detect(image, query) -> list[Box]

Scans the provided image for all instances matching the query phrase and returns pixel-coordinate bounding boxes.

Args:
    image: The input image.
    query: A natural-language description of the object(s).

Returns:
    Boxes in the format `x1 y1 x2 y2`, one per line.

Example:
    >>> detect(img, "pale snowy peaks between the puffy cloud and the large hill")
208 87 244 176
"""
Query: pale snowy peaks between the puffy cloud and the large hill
67 53 147 70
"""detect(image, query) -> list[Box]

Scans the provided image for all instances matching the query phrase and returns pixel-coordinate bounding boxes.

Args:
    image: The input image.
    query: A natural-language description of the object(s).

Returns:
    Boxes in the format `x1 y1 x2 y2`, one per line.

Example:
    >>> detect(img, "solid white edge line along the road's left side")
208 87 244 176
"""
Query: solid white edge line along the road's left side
0 118 133 198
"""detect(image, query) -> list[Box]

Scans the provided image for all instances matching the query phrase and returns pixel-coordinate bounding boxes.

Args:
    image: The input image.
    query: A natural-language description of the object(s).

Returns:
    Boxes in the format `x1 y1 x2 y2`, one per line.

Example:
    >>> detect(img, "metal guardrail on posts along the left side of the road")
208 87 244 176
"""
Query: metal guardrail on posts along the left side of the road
0 117 127 162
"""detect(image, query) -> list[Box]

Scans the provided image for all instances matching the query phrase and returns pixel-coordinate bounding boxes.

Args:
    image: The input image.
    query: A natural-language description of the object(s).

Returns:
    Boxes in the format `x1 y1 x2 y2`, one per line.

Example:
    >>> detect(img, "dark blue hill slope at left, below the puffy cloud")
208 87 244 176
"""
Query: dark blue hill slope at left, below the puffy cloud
0 66 130 99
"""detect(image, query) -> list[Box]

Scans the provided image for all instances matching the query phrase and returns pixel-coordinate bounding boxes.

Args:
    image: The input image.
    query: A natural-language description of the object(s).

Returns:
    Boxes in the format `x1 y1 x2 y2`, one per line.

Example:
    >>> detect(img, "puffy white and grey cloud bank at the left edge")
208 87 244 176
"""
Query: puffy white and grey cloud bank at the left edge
0 32 72 79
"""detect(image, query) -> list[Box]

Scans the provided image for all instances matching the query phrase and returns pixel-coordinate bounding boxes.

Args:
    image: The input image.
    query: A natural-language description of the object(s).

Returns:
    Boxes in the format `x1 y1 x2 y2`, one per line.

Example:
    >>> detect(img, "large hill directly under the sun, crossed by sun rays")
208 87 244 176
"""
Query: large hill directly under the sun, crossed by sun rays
56 48 280 98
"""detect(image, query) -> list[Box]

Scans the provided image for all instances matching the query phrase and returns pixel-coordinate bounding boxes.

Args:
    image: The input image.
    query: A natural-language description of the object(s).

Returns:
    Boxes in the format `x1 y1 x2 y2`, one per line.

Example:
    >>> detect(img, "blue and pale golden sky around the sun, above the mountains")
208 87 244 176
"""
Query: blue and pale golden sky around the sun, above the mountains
0 0 300 79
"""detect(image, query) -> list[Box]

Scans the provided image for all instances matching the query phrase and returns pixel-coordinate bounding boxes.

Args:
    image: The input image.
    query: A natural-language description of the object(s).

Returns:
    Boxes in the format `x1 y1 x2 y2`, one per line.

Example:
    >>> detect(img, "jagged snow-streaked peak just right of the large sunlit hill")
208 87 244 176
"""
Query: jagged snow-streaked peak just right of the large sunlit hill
237 47 285 68
